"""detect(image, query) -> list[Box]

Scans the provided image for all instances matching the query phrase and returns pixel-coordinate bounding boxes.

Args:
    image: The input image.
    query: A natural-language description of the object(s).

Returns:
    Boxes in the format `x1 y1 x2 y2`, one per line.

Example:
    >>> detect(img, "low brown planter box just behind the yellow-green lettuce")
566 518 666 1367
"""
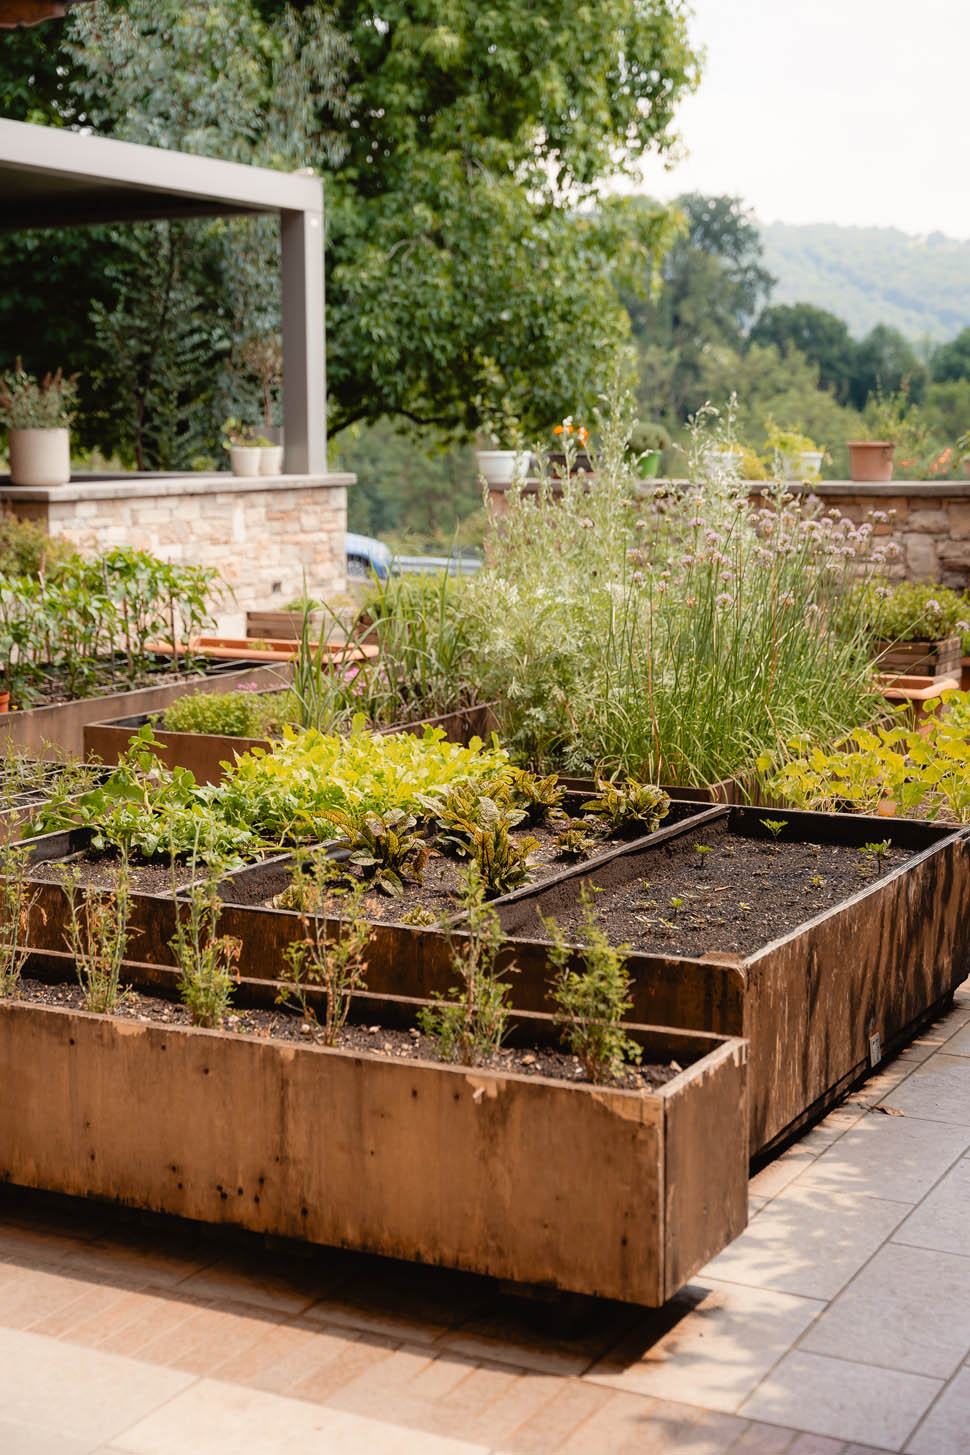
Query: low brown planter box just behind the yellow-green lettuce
84 703 494 783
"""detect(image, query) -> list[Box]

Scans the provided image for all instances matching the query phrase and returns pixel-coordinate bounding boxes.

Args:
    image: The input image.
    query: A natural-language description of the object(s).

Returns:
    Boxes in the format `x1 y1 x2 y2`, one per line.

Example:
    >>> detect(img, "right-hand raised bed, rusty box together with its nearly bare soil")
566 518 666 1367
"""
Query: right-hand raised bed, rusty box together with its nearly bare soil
485 808 970 1154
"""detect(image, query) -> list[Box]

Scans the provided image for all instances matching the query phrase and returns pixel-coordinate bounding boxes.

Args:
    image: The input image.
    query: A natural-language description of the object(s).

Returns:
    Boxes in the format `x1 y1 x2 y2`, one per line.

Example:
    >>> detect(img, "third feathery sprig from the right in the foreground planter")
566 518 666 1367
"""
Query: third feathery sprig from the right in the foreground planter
276 857 371 1046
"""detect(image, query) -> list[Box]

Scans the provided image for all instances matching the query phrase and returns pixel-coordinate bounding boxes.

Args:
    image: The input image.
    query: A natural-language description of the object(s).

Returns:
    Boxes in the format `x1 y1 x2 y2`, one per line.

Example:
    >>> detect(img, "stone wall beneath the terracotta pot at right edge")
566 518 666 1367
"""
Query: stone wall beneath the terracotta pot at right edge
767 480 970 591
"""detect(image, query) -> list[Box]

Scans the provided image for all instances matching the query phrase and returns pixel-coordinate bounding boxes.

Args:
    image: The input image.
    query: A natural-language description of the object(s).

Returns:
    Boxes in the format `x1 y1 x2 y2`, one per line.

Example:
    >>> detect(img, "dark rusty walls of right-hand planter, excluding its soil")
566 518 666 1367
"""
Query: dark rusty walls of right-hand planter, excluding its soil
488 808 970 1155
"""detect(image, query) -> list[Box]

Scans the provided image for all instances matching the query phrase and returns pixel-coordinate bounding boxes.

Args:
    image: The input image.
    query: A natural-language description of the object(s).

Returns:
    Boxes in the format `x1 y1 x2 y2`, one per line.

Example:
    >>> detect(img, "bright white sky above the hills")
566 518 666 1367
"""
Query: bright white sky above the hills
634 0 970 237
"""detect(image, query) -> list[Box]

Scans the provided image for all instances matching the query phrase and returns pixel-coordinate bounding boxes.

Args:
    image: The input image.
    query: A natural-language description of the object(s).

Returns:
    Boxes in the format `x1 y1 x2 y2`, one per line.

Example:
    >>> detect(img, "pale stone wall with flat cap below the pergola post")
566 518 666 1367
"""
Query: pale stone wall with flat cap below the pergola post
0 474 355 633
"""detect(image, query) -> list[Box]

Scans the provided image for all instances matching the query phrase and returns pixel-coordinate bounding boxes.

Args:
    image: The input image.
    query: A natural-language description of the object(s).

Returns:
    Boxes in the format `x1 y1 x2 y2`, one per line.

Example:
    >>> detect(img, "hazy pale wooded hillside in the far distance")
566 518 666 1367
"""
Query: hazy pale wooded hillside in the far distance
761 223 970 342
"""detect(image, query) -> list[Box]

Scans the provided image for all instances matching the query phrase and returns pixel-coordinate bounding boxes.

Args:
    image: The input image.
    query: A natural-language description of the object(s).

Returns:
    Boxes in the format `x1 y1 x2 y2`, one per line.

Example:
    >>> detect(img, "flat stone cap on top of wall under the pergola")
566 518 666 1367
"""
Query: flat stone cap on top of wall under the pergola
0 470 356 505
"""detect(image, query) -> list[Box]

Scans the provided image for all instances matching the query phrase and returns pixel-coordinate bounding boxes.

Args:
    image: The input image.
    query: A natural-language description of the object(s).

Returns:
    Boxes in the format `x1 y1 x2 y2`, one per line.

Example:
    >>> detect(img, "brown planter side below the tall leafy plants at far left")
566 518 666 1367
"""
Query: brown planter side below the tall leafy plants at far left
0 663 292 758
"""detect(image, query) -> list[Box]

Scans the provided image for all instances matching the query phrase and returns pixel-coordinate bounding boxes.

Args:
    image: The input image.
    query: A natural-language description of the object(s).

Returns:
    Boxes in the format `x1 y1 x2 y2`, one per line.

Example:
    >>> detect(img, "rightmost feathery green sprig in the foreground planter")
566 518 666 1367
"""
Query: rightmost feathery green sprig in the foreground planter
541 886 641 1085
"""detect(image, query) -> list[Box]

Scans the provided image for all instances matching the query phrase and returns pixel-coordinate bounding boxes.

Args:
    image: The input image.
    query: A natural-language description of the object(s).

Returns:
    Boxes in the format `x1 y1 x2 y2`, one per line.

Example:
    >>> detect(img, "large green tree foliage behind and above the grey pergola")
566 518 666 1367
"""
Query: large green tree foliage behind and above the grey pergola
0 0 698 464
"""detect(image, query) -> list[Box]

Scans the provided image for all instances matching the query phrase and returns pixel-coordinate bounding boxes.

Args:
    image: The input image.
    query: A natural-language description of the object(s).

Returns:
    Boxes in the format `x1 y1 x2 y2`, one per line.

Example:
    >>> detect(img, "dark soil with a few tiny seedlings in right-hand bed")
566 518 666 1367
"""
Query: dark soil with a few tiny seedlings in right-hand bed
503 824 912 959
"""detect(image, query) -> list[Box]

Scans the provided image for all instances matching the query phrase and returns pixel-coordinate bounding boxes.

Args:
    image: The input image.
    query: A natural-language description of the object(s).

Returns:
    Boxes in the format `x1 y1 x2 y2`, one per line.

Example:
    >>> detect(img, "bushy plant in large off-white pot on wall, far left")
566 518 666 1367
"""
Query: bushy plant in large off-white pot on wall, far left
0 358 77 485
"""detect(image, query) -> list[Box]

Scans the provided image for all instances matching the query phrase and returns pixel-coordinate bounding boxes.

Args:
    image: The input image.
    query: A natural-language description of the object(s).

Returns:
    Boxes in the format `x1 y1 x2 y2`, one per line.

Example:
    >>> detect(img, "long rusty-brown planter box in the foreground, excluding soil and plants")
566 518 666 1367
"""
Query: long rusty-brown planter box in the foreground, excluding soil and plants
0 1001 747 1305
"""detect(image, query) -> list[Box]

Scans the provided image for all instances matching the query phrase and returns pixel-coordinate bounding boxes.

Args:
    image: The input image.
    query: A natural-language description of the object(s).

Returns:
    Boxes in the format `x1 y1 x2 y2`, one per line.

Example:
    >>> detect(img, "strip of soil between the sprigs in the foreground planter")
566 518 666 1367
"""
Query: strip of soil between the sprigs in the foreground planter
17 978 684 1091
